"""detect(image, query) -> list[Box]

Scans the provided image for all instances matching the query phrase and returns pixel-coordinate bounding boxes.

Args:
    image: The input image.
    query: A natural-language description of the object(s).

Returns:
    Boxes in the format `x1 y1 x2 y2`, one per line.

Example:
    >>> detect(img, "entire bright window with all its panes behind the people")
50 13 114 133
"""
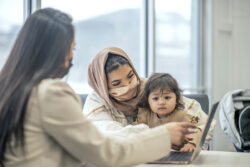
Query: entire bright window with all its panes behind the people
0 0 204 93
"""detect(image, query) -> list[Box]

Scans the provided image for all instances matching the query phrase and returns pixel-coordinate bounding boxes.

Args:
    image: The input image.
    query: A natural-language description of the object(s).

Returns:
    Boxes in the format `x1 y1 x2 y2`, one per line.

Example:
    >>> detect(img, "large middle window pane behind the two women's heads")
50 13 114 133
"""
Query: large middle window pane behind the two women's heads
41 0 142 93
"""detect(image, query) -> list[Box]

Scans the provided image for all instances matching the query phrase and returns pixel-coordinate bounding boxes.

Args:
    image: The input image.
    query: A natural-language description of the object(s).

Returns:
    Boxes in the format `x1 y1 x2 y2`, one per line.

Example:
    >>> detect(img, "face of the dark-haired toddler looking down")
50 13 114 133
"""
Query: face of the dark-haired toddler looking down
148 89 176 117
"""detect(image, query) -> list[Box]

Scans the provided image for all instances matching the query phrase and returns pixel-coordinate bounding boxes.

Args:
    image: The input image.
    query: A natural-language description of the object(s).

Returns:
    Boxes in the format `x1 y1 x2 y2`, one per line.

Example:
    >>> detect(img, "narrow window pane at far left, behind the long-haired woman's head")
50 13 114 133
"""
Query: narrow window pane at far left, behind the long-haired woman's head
0 0 23 70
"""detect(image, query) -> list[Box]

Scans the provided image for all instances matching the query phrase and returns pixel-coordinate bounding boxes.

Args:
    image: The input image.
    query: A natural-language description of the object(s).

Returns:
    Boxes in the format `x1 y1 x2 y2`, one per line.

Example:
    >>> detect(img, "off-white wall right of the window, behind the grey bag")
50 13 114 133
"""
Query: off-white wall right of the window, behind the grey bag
205 0 250 151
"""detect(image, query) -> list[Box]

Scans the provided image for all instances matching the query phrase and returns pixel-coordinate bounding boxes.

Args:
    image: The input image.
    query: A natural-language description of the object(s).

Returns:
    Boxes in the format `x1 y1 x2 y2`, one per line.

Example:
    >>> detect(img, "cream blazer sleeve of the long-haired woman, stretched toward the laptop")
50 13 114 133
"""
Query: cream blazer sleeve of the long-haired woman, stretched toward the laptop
38 82 170 167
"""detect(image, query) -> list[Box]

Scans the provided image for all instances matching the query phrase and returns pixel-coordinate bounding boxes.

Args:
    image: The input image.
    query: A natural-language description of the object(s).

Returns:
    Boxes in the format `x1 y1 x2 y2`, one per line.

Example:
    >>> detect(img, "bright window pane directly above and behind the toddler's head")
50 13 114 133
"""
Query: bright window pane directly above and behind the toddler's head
155 0 200 93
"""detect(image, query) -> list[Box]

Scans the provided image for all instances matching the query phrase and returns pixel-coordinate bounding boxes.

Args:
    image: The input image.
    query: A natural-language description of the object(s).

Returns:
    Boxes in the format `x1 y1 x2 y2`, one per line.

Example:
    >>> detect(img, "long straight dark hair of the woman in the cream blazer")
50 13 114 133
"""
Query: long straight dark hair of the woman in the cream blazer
0 8 74 166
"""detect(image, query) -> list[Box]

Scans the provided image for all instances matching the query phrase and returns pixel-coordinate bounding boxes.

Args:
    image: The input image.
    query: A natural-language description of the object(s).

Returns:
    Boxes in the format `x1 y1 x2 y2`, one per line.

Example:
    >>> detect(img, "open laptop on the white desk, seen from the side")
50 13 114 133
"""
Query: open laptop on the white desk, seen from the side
148 103 219 164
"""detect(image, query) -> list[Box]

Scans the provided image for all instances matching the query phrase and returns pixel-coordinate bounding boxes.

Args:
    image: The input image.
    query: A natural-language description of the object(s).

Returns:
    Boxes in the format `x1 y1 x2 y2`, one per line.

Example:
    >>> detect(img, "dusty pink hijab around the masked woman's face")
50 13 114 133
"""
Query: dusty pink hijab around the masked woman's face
88 47 145 117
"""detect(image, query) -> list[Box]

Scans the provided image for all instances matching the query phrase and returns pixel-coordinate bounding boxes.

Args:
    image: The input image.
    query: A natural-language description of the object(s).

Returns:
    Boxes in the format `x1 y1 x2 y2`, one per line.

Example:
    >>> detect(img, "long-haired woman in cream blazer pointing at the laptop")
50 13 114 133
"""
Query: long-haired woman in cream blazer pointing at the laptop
0 8 194 167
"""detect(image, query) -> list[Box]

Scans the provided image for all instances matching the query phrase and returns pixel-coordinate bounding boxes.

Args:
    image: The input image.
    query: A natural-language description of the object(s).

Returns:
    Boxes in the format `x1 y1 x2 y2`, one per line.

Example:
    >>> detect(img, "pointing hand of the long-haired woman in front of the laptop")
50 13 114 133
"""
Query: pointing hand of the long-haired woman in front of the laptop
166 122 197 150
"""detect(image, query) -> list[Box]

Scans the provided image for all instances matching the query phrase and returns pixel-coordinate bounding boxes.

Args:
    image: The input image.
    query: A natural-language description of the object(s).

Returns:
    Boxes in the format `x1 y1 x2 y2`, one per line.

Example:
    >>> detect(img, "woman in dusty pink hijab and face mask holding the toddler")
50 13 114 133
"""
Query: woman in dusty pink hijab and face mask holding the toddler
83 47 196 145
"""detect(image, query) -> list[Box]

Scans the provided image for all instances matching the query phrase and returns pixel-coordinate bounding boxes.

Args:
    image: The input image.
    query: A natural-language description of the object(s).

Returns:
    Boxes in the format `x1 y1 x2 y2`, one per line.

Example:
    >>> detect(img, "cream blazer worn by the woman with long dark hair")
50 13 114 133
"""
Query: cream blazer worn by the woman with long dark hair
5 79 170 167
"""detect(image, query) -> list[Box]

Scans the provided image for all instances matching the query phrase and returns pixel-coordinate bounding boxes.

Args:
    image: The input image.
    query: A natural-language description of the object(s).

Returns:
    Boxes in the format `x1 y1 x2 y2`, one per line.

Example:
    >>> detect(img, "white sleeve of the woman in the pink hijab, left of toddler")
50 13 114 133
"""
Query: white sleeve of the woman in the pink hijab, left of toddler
83 94 149 137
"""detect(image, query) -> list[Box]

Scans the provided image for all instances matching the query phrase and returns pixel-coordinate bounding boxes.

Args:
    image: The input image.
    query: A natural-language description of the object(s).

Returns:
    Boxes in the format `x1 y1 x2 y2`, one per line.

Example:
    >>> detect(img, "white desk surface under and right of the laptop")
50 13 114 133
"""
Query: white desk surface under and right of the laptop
134 151 250 167
